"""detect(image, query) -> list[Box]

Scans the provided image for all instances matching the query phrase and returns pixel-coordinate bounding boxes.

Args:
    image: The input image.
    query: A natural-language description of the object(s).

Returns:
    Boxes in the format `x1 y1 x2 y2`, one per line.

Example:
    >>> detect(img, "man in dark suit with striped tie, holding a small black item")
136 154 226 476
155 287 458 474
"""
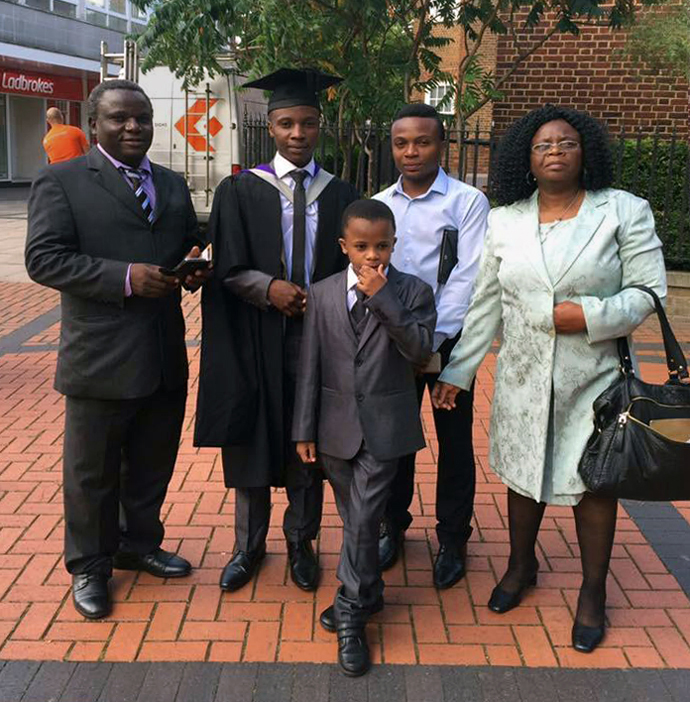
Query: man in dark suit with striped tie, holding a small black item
26 80 208 619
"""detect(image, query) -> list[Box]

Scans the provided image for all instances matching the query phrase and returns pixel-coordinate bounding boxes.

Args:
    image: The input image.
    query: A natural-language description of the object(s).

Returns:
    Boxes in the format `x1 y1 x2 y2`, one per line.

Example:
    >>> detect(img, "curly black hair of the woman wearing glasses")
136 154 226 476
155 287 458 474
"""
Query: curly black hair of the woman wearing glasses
491 104 613 205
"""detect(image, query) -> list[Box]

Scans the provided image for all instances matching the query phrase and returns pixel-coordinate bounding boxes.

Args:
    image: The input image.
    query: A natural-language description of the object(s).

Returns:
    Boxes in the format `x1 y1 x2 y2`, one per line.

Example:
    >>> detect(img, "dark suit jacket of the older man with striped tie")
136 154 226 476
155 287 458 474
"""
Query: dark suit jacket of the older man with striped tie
26 149 199 399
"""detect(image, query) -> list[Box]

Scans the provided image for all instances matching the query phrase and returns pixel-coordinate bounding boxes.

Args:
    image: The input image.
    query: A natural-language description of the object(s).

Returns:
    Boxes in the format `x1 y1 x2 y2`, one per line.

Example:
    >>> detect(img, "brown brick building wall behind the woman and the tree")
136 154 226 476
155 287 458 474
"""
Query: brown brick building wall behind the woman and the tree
420 7 690 137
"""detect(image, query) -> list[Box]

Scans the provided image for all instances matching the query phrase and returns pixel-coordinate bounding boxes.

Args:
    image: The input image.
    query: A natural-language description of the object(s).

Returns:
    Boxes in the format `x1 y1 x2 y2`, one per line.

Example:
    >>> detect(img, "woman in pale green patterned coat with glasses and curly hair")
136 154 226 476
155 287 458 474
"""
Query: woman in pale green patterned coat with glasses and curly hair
432 105 666 652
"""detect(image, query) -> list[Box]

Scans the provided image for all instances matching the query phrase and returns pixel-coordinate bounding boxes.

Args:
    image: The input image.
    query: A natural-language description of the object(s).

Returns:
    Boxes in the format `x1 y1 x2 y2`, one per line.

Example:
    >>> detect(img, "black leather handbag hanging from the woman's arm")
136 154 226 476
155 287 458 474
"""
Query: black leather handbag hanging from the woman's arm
578 285 690 501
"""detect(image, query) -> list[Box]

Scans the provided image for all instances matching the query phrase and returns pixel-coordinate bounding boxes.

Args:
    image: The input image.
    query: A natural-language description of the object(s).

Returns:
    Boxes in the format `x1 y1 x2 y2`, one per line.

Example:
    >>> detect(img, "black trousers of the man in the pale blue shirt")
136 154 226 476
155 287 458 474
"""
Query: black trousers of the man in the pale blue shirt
385 334 476 545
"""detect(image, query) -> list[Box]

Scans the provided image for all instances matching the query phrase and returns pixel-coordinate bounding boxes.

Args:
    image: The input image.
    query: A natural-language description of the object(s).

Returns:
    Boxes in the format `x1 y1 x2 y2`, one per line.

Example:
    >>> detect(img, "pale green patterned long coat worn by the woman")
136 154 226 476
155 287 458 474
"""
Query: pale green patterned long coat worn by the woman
440 189 666 500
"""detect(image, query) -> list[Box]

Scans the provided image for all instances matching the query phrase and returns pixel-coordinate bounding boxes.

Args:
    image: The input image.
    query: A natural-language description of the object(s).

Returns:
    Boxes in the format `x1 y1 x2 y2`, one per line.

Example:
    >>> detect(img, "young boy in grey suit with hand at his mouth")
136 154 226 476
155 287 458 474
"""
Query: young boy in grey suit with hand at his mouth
292 200 436 676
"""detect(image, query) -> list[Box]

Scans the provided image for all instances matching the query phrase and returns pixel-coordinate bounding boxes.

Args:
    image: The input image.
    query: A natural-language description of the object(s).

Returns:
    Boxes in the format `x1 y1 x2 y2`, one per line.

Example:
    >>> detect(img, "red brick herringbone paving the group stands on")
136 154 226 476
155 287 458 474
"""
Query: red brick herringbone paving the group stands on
0 283 690 668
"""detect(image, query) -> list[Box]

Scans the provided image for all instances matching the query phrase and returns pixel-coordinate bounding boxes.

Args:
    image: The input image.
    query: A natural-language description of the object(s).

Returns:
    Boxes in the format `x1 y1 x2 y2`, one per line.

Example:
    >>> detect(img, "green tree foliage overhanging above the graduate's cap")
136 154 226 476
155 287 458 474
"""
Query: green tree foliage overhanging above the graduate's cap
134 0 656 125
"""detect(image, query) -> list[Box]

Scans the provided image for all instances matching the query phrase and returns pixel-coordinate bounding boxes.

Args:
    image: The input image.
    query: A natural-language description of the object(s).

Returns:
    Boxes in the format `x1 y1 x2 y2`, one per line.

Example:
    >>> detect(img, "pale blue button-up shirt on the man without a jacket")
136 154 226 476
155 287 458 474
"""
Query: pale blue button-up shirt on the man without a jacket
374 168 490 351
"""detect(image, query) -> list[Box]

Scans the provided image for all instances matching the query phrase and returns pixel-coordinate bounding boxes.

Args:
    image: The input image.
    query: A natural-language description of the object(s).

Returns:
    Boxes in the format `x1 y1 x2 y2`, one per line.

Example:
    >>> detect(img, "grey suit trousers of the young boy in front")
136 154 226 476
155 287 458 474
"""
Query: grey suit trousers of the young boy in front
321 445 398 623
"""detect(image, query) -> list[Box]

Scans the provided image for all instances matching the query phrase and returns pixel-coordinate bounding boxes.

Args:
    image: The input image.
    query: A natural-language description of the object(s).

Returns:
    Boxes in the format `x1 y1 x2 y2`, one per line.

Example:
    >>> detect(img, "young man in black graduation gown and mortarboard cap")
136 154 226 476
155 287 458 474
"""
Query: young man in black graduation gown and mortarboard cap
195 69 359 590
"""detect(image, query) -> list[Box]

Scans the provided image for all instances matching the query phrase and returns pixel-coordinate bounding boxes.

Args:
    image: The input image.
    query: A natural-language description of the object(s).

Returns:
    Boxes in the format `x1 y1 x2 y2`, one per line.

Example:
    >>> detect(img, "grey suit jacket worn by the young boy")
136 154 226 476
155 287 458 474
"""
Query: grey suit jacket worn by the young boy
292 266 436 461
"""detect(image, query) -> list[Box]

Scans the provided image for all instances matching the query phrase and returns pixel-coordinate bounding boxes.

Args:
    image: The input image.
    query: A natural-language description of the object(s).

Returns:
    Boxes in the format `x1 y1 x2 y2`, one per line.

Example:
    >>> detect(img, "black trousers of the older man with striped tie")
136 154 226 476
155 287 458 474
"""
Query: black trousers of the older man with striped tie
63 385 187 575
